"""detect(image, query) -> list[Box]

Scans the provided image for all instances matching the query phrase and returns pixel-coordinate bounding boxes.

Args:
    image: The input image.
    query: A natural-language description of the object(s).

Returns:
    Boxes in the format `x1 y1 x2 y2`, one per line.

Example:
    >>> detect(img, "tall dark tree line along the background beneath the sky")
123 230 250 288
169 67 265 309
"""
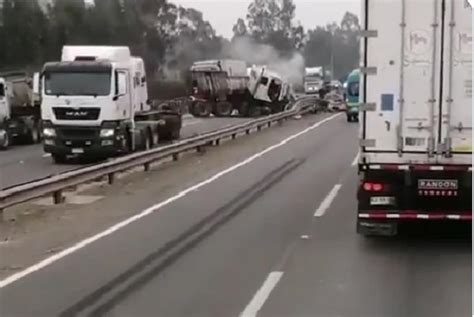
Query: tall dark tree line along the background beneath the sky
0 0 359 94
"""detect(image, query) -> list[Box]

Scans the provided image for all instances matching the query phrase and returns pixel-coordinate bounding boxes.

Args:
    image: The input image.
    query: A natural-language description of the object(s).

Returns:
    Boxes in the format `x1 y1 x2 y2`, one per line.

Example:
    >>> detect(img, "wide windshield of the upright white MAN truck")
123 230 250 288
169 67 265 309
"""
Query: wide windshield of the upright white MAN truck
45 72 111 96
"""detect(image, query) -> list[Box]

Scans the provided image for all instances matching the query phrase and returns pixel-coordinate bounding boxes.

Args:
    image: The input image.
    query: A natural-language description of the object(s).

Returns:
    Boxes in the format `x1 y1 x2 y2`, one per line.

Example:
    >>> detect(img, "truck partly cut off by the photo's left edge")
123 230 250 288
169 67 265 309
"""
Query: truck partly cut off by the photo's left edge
0 71 41 150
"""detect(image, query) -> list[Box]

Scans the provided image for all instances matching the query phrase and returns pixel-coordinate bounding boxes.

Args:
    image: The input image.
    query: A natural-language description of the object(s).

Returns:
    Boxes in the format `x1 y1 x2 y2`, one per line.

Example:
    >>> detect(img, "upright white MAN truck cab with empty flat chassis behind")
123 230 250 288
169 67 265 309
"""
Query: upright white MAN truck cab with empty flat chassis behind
41 46 181 163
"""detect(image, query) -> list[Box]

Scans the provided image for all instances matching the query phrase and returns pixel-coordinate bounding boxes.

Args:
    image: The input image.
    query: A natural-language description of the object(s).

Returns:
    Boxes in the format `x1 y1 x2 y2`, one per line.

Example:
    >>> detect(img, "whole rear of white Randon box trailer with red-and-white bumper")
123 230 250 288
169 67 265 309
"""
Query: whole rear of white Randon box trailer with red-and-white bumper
357 0 472 235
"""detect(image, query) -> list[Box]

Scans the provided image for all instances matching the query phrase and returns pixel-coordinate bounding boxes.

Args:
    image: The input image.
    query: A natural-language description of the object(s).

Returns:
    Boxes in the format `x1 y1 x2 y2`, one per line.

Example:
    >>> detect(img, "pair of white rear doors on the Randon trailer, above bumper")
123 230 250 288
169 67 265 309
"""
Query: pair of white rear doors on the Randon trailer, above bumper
360 0 472 163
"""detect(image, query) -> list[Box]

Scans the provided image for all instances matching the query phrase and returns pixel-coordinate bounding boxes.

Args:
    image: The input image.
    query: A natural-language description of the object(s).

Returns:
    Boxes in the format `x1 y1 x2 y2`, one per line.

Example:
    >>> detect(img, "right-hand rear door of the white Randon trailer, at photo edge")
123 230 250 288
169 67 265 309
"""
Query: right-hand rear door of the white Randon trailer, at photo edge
439 0 472 164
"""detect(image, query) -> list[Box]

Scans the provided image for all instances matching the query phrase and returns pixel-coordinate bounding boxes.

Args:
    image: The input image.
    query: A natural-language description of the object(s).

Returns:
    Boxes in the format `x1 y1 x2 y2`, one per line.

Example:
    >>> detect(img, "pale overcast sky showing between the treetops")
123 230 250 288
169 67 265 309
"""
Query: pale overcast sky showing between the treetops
169 0 361 38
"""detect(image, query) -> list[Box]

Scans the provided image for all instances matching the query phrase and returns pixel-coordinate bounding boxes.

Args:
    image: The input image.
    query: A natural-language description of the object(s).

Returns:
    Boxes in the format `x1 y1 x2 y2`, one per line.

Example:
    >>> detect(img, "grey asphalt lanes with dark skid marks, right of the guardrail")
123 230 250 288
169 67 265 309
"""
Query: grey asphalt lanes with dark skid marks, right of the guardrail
0 115 471 317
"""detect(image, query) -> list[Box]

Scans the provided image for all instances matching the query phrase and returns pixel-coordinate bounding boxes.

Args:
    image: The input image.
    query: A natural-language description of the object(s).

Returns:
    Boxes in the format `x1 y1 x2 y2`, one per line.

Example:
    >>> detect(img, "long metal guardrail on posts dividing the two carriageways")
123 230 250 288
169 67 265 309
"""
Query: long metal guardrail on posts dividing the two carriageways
0 97 314 213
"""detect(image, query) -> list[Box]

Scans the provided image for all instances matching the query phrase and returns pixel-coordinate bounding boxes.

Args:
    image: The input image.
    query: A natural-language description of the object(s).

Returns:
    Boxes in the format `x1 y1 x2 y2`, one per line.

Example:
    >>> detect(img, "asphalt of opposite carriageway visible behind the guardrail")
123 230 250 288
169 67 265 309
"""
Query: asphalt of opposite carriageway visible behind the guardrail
0 117 249 189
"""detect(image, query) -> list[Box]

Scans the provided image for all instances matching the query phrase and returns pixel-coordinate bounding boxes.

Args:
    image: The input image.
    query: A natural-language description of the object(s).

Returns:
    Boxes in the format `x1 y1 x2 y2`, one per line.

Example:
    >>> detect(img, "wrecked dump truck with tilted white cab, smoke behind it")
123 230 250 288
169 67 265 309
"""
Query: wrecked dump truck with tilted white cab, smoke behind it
189 60 290 117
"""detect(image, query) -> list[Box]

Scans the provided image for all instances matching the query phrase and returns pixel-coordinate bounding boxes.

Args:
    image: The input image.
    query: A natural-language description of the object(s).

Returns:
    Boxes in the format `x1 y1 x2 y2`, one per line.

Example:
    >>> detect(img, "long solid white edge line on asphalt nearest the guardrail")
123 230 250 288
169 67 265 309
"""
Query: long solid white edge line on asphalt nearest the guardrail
0 113 340 288
